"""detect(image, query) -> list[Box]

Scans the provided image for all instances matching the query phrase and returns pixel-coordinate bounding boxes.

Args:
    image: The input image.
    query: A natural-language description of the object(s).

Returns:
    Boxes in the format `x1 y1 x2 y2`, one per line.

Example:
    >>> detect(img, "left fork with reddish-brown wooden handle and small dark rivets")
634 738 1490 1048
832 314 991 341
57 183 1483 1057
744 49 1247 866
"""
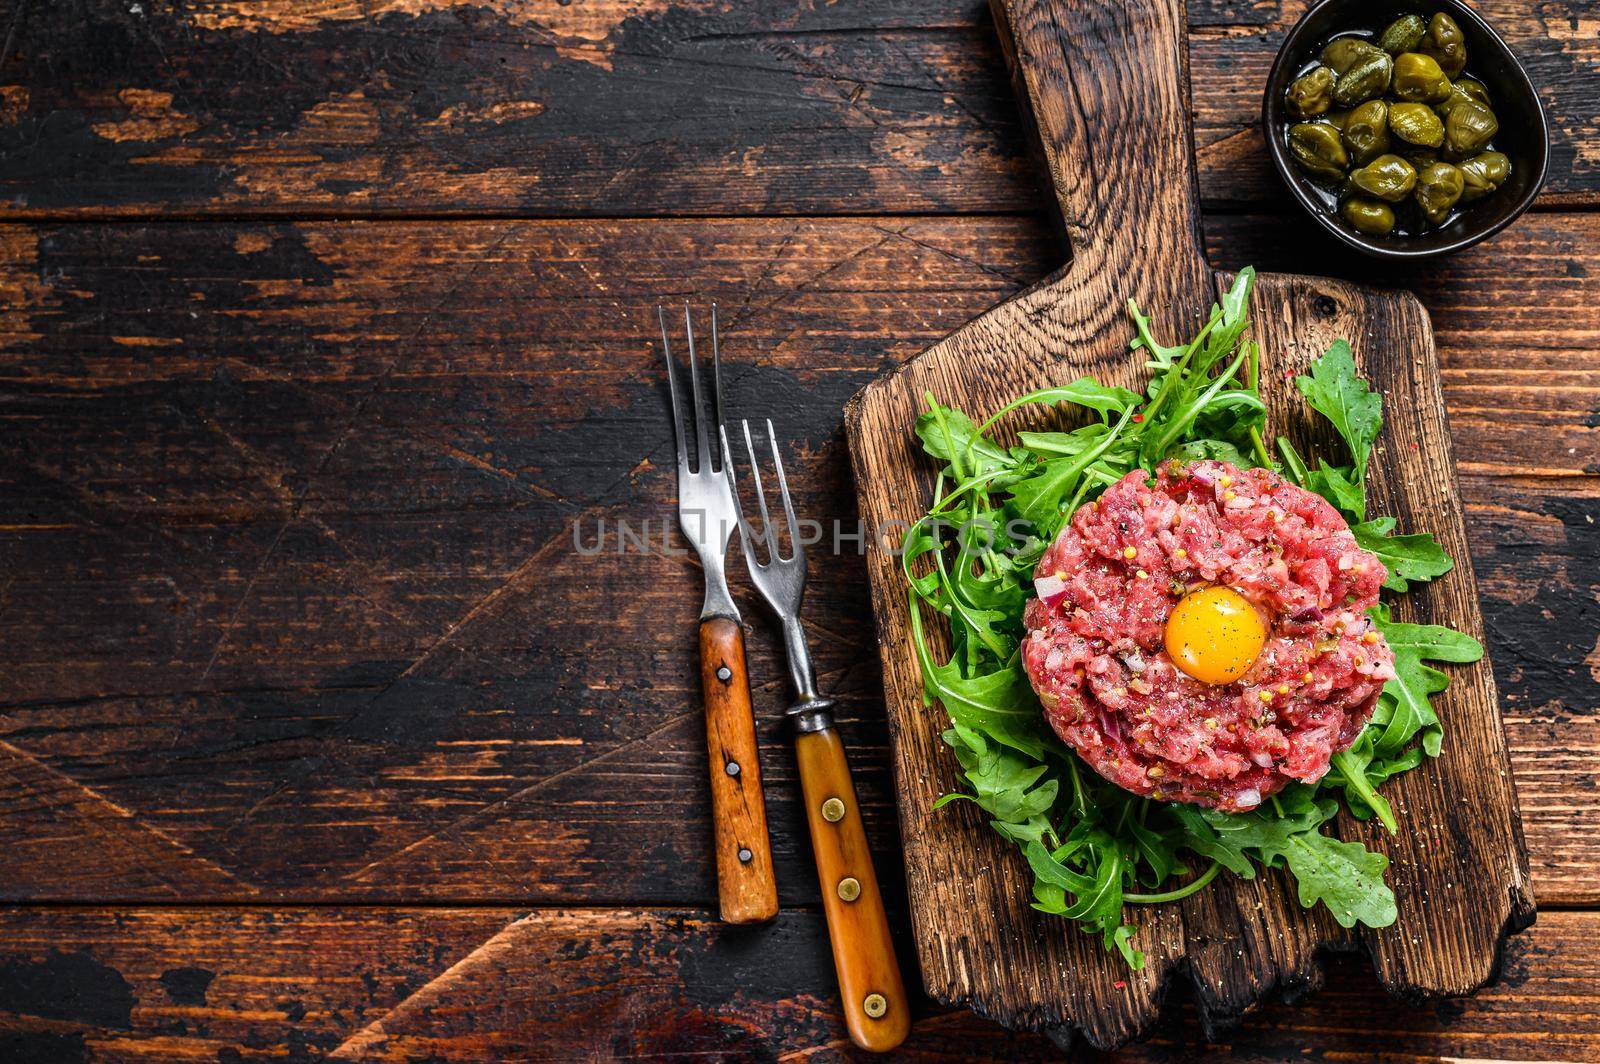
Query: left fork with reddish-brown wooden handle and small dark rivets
656 304 778 923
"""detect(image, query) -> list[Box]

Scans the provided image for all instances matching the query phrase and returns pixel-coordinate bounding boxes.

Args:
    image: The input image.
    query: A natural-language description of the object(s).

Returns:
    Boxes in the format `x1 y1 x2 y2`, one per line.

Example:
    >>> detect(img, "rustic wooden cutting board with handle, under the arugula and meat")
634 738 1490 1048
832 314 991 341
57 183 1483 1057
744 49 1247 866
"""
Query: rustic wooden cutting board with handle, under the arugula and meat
845 0 1534 1046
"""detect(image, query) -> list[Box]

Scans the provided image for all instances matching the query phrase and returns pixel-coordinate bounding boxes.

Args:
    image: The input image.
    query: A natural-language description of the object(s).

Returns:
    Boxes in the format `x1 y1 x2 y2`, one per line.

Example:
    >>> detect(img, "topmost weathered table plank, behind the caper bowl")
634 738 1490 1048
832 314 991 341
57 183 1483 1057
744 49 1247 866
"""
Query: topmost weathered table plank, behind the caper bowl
0 0 1600 216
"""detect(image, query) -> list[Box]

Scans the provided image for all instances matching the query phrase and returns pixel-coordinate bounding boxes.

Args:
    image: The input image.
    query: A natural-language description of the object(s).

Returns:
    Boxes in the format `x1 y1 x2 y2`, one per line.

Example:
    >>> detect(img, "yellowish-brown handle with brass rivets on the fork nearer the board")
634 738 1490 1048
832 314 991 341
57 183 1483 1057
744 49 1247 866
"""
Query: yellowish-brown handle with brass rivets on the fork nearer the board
795 726 910 1053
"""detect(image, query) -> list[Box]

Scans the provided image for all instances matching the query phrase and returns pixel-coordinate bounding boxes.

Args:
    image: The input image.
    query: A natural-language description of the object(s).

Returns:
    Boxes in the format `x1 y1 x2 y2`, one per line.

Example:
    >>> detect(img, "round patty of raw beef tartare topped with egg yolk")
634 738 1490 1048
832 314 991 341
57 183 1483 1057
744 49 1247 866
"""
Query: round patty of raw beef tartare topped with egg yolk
1022 461 1394 813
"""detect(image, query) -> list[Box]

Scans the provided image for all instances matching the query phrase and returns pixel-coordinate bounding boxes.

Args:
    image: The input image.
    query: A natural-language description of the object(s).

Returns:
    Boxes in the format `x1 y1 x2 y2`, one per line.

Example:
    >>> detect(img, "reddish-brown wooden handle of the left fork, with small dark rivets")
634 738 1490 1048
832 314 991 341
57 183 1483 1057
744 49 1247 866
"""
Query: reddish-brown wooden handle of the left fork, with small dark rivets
701 618 778 923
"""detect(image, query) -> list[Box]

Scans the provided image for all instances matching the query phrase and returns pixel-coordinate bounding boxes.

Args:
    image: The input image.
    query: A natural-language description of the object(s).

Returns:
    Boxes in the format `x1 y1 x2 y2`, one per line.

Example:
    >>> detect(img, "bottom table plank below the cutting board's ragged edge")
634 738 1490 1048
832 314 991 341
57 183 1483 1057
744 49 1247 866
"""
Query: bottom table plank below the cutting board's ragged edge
0 909 1600 1064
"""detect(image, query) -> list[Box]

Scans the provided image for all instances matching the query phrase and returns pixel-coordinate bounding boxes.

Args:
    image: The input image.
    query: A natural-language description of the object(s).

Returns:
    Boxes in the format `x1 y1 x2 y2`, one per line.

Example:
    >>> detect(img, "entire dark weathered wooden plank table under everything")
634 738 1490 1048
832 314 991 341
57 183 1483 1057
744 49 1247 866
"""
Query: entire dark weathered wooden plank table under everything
0 0 1600 1062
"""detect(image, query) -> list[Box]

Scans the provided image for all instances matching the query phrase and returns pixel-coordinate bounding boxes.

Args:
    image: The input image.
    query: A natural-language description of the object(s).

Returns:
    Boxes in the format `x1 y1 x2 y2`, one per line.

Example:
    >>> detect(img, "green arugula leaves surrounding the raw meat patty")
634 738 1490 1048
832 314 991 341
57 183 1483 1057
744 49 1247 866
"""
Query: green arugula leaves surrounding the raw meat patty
902 269 1483 968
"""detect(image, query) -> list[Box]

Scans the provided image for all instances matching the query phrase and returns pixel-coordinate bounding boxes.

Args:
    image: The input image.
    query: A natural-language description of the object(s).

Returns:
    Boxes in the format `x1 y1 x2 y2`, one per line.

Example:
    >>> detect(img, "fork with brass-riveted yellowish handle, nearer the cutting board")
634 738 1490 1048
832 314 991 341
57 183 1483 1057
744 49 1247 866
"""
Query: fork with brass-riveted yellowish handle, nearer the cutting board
722 419 910 1053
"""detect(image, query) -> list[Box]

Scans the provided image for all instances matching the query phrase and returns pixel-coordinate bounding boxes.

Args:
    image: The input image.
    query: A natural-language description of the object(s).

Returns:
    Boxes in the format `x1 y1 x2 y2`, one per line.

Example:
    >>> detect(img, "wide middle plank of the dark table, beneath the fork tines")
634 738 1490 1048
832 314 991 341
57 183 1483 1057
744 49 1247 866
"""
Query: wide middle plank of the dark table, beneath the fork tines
0 214 1600 904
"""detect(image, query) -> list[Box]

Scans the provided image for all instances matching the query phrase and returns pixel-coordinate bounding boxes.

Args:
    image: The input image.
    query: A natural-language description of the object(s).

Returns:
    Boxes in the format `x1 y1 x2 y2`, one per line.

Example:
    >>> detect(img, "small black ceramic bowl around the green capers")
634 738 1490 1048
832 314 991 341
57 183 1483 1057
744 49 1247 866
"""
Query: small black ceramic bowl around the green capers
1261 0 1550 259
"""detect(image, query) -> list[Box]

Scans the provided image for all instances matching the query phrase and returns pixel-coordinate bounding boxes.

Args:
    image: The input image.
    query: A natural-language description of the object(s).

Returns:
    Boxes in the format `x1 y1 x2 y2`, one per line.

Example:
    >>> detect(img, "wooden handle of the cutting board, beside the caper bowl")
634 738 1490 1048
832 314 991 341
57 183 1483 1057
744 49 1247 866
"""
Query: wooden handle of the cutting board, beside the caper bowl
990 0 1206 291
